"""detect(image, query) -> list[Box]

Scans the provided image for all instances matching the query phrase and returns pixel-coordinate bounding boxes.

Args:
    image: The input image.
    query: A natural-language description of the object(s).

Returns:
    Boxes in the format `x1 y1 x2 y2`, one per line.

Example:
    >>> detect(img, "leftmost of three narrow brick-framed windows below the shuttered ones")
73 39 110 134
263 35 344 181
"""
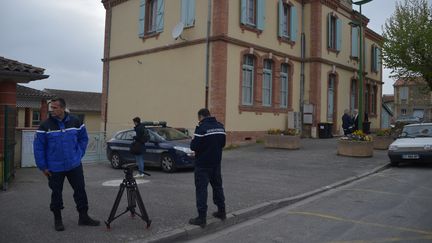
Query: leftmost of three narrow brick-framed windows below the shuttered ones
242 55 255 105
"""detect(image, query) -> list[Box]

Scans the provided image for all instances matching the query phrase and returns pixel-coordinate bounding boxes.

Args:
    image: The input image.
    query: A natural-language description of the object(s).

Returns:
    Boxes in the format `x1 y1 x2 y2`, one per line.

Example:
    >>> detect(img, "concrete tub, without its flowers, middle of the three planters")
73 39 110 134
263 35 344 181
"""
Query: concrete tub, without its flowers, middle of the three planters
337 139 374 157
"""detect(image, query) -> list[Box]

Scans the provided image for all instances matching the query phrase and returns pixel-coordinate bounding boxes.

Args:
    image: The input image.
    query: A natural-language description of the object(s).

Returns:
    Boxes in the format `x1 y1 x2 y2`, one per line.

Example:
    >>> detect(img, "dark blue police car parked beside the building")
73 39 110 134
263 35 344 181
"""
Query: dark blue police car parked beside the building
106 122 195 172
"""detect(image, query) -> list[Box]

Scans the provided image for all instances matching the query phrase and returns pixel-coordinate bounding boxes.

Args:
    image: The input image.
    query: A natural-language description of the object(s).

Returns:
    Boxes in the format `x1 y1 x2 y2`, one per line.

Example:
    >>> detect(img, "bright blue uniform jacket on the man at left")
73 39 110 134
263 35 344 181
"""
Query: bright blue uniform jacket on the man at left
33 113 88 172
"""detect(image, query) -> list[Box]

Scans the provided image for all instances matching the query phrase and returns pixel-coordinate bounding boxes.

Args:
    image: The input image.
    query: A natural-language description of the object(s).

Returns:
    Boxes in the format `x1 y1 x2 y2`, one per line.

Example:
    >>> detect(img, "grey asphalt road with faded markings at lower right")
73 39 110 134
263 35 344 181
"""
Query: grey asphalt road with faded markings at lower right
191 164 432 243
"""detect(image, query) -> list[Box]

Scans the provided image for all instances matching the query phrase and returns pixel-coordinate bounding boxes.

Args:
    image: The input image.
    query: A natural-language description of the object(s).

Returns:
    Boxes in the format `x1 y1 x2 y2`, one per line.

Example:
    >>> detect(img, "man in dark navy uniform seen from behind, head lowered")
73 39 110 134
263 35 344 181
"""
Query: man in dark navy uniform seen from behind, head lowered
189 109 226 227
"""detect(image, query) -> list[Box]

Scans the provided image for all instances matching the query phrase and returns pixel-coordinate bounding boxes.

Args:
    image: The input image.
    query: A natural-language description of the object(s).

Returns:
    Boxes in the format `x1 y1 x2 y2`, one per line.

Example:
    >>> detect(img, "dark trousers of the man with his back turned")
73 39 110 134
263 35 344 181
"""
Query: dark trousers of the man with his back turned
195 165 225 218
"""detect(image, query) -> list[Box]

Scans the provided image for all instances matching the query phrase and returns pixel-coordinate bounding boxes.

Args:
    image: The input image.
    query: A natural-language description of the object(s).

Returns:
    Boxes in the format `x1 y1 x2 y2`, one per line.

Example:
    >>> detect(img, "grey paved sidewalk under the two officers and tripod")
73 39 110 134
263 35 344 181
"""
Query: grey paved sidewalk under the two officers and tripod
0 139 388 242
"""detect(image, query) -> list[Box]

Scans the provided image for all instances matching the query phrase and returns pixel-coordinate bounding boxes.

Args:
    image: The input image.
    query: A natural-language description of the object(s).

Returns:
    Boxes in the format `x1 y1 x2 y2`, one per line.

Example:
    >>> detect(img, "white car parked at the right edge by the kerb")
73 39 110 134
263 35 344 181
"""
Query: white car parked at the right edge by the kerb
388 123 432 166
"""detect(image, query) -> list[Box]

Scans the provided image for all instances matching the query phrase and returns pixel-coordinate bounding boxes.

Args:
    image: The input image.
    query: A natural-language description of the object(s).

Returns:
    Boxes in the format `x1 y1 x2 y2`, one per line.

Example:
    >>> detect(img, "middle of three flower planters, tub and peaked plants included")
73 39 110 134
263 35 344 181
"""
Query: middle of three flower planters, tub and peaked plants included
337 130 373 157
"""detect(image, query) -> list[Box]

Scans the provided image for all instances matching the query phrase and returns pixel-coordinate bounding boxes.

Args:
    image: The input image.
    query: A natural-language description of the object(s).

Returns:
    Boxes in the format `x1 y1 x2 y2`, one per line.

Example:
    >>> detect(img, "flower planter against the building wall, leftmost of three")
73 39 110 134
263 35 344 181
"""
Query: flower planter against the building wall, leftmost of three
264 128 300 149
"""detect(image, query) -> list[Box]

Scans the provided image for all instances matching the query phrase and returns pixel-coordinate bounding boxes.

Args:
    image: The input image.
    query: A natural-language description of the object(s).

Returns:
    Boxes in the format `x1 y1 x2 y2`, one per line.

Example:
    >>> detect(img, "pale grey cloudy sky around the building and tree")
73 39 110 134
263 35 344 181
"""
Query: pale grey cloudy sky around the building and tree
0 0 396 94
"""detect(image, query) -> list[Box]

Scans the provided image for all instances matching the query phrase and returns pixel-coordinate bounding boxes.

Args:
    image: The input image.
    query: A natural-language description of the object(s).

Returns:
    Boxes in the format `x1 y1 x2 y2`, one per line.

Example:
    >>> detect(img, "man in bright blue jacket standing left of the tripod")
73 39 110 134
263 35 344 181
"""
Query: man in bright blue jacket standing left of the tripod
33 98 100 231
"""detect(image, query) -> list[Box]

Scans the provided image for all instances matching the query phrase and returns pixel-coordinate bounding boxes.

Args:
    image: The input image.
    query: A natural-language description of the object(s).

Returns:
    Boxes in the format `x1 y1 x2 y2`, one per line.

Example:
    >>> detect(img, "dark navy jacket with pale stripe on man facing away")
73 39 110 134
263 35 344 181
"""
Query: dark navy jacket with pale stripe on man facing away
190 117 226 167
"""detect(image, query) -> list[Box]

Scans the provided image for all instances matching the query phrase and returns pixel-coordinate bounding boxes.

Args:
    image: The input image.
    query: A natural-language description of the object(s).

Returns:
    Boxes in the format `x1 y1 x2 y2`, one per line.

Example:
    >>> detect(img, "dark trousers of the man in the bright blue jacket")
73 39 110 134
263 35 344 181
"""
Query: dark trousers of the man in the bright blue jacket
48 165 88 213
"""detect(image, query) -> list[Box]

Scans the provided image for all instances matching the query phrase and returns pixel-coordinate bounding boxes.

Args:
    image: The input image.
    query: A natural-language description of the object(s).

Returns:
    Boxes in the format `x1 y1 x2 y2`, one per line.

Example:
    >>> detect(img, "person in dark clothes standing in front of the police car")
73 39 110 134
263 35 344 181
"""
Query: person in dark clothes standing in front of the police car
132 117 150 178
